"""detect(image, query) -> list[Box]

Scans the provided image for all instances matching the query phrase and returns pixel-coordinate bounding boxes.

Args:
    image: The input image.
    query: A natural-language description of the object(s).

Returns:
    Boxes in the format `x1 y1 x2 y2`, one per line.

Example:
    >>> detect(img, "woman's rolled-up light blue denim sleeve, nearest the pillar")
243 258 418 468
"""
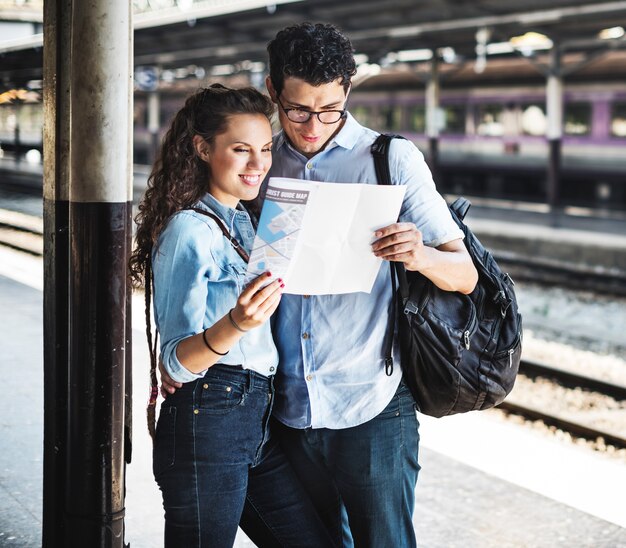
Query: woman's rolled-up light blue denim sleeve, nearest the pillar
152 213 213 383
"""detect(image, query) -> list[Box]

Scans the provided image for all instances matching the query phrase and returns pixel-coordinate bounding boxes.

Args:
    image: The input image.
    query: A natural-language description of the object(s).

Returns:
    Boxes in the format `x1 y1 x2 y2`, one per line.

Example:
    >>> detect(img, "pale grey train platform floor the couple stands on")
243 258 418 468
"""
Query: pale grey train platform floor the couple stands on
0 247 626 548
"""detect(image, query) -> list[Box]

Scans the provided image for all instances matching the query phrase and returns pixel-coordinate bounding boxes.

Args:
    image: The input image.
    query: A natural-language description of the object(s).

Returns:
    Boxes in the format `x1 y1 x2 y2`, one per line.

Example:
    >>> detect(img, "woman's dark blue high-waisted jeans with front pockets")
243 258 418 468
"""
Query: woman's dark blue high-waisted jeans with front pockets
153 364 332 548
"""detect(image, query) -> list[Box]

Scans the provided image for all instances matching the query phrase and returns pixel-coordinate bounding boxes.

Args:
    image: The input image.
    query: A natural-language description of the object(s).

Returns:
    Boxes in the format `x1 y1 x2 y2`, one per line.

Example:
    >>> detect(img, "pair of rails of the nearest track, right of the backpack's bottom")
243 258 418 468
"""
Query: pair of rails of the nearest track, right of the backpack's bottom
498 360 626 449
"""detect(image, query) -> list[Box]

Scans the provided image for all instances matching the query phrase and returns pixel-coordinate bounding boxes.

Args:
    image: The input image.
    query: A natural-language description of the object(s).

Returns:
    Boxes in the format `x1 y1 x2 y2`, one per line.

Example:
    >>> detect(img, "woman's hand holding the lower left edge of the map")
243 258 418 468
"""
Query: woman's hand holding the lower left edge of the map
231 272 285 331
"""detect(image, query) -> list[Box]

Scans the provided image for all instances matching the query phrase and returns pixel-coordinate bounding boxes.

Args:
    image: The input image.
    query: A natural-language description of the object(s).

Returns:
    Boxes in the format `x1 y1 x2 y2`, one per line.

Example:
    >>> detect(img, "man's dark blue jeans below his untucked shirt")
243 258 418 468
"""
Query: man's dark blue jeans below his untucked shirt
274 383 420 548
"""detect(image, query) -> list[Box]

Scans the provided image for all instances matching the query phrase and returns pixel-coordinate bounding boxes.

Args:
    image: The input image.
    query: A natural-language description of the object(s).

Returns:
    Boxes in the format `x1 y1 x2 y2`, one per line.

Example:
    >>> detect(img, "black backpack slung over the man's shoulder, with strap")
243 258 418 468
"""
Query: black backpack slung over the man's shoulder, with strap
372 135 522 417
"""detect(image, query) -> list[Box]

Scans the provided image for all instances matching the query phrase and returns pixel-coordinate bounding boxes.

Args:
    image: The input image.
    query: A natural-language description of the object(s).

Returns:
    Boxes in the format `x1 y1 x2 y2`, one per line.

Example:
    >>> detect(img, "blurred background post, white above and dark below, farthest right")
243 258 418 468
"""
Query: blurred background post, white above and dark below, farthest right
546 43 563 212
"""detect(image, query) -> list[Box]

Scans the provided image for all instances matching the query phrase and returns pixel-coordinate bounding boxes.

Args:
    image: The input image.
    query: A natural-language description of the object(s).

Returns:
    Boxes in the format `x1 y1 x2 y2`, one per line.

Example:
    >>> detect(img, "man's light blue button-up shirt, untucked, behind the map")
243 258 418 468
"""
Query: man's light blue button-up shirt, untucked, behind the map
268 114 463 429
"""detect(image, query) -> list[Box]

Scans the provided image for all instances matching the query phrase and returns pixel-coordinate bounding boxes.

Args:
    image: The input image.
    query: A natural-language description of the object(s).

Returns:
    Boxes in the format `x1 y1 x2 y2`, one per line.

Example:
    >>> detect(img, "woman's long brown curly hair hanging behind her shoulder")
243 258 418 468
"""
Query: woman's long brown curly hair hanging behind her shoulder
128 84 274 439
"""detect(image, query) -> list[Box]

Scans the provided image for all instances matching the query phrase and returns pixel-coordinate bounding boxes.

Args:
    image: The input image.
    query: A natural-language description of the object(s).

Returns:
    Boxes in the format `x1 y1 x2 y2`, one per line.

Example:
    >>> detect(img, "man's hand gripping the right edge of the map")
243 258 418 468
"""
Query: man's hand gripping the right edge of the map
372 223 432 270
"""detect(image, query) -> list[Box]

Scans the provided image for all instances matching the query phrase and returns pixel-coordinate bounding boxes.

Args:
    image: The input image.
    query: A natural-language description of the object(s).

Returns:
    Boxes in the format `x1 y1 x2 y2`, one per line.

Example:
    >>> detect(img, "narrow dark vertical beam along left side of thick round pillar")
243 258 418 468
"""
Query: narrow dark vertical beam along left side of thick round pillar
42 0 72 548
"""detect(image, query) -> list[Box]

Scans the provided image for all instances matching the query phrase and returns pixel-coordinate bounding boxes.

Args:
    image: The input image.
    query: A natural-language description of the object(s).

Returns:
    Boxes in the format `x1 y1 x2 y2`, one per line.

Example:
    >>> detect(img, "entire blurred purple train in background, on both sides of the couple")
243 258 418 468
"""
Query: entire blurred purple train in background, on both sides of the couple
0 63 626 211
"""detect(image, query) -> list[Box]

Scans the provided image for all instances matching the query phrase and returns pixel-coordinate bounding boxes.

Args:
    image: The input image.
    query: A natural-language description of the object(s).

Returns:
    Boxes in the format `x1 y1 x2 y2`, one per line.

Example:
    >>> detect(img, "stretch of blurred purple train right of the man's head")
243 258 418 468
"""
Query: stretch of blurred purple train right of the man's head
349 82 626 210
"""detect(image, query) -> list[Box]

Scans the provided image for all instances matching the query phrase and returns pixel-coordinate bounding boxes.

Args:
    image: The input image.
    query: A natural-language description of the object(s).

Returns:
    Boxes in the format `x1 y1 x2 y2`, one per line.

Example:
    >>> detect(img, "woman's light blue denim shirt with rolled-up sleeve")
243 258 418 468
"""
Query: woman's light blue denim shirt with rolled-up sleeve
152 194 278 382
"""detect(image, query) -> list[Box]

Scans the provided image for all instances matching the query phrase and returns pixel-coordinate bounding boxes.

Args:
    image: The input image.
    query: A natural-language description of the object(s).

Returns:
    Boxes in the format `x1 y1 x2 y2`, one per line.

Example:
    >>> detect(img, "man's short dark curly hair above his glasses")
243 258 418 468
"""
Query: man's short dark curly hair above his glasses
267 23 356 95
